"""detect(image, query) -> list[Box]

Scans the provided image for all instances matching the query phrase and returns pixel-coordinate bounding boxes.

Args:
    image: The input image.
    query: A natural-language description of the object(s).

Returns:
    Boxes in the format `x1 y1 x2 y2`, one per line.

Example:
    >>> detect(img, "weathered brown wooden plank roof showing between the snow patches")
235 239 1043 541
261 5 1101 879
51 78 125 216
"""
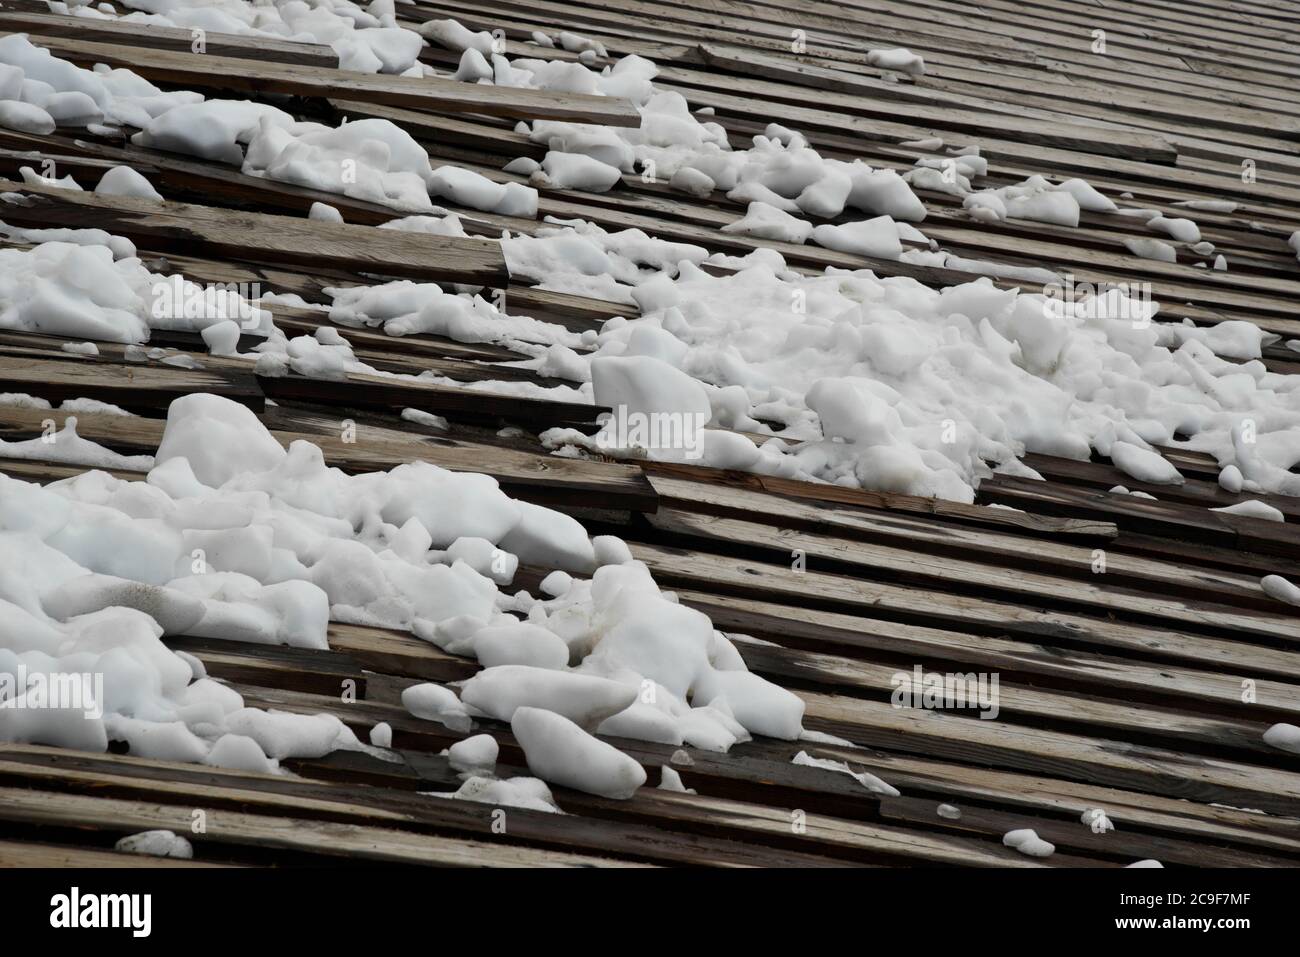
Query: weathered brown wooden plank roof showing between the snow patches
0 0 1300 867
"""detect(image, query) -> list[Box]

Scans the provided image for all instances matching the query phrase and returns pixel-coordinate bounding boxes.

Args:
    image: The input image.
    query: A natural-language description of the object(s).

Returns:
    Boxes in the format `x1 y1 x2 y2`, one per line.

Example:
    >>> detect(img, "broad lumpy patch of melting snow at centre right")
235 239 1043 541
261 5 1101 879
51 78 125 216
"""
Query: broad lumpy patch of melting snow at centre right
527 250 1300 501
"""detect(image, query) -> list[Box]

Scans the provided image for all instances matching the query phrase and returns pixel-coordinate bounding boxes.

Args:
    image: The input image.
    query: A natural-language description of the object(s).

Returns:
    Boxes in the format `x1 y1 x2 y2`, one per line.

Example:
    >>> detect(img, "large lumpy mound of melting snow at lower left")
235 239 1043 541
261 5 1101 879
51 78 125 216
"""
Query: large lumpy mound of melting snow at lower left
0 382 802 793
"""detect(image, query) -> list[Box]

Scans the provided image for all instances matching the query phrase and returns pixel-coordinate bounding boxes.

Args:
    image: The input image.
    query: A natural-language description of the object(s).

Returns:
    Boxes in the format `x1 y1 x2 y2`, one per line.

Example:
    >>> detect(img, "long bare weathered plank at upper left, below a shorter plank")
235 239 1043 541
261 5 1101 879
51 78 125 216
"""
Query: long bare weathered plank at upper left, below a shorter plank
20 29 641 126
